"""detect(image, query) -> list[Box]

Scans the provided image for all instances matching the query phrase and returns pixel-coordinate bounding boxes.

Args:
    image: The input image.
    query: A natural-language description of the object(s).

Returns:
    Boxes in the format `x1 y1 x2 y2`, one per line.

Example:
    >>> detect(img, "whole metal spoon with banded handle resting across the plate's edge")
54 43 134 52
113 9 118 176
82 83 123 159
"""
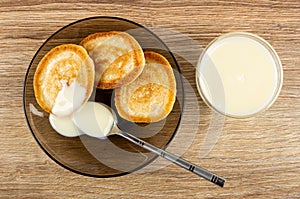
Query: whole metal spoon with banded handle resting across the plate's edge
74 103 226 187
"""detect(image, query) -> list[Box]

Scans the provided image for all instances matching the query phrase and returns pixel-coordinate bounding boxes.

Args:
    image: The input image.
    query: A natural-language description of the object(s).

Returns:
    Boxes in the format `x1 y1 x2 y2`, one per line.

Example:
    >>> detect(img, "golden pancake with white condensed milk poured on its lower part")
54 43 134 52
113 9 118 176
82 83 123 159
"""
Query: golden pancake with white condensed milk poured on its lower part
33 44 95 117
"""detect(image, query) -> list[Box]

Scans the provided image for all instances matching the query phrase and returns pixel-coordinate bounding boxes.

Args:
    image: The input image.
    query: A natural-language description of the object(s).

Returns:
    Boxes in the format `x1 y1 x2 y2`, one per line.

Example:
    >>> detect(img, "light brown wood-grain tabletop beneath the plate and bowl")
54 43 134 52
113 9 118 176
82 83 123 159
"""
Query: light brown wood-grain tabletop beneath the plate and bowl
0 0 300 198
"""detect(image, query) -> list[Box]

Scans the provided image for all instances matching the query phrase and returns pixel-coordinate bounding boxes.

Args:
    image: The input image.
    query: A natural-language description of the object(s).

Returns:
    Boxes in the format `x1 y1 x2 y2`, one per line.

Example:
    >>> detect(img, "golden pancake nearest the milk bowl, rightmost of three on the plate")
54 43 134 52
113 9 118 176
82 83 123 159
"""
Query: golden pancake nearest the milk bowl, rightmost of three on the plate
114 52 176 123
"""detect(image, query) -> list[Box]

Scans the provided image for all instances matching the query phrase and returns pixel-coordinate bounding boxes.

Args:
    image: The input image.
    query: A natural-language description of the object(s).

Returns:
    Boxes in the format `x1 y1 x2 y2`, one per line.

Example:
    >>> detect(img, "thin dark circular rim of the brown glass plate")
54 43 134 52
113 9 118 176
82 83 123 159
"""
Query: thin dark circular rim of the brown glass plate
22 16 185 178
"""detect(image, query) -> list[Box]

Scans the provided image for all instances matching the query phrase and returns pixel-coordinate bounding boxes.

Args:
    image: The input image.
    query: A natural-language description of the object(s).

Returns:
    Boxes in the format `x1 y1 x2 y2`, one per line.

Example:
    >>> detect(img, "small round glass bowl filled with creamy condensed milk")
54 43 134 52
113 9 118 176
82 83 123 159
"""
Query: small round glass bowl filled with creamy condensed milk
196 32 283 118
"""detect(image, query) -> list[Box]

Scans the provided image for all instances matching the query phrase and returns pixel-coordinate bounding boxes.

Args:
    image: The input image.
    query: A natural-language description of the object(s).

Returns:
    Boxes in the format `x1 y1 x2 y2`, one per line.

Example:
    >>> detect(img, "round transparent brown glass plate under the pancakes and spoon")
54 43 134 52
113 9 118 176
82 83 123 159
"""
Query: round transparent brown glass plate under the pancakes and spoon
23 17 184 177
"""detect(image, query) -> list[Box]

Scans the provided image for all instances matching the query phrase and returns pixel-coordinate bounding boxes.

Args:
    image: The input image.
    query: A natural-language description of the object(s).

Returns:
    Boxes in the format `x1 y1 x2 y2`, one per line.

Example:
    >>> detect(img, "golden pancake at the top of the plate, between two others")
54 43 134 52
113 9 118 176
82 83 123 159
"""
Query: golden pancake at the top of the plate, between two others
80 31 145 89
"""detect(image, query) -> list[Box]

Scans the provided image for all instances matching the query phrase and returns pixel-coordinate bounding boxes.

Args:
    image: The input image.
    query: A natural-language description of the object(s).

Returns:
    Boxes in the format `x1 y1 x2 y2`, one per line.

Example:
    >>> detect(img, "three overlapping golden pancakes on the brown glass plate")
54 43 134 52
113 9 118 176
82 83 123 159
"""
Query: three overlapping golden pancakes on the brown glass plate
34 31 176 123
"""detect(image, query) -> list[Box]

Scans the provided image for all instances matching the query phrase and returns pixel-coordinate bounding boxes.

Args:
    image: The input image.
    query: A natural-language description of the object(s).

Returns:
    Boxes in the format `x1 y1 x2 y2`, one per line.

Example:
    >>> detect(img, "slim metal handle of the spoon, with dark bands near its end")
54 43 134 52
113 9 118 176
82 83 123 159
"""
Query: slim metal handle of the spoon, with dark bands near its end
118 131 226 187
